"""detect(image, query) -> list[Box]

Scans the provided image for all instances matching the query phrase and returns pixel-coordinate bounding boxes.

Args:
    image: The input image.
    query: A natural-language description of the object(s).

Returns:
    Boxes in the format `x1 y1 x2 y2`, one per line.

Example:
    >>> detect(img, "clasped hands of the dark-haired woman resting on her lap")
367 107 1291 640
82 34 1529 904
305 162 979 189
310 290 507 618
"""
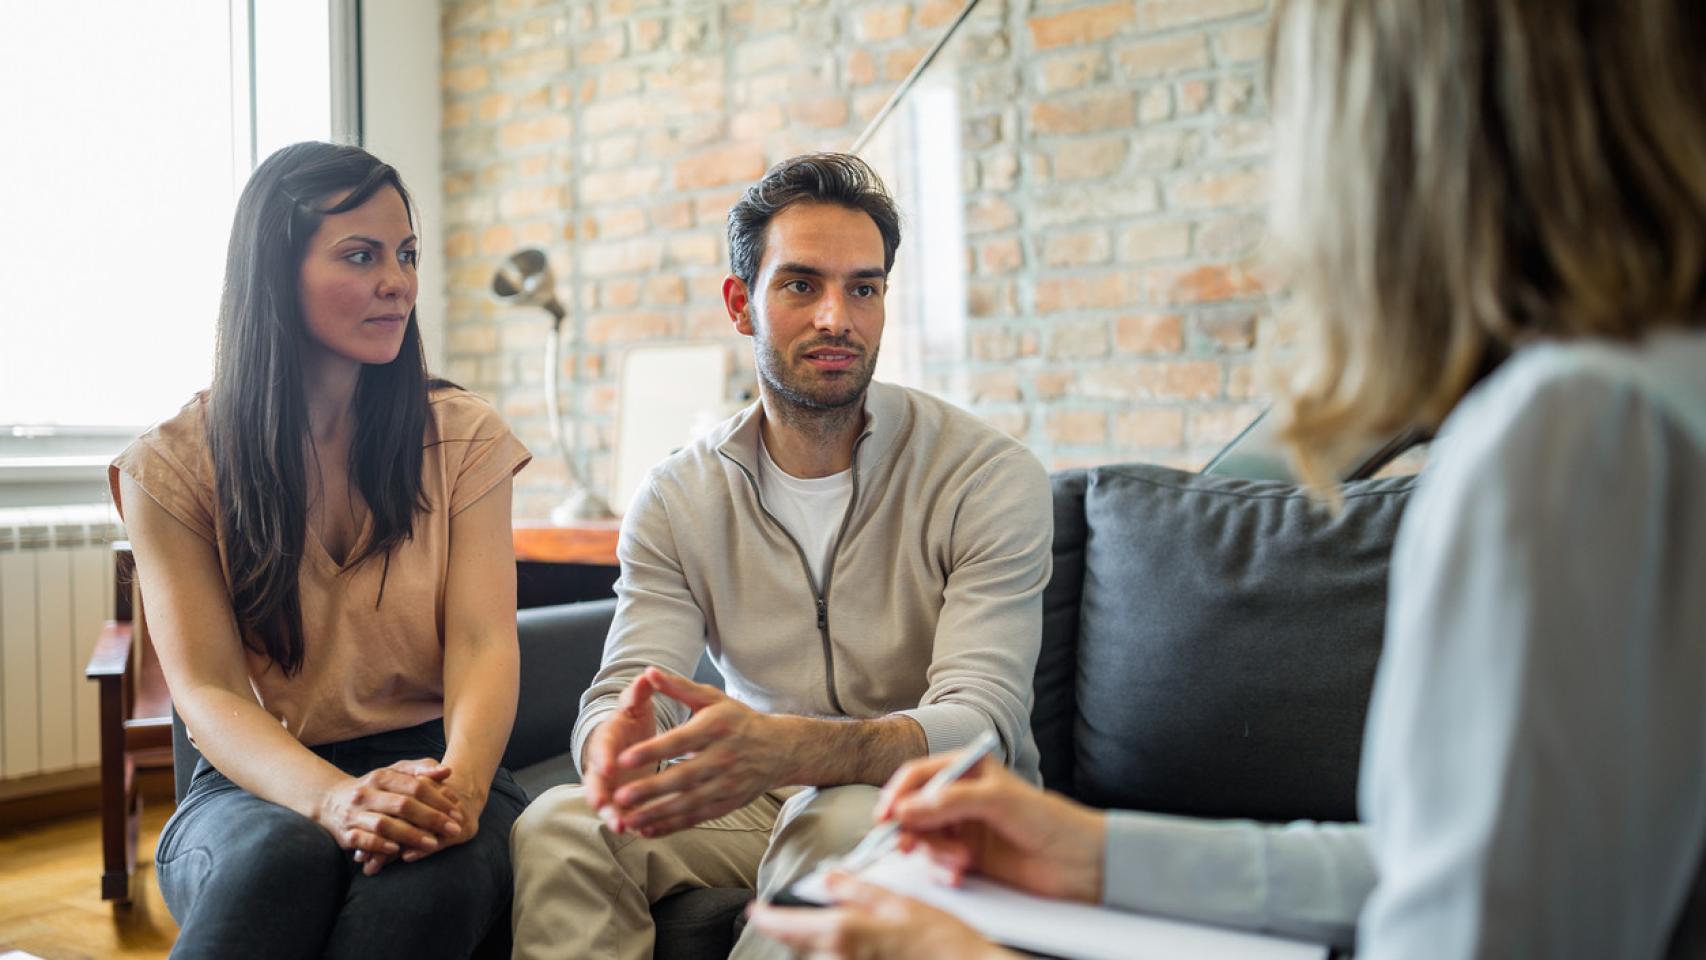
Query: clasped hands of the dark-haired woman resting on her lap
314 757 486 876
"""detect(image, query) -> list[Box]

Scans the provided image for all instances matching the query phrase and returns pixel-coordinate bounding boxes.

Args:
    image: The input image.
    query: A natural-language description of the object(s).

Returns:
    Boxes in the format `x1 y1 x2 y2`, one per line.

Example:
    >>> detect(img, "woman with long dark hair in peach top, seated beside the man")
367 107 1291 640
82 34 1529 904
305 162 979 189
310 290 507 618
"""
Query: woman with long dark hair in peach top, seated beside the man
109 143 529 957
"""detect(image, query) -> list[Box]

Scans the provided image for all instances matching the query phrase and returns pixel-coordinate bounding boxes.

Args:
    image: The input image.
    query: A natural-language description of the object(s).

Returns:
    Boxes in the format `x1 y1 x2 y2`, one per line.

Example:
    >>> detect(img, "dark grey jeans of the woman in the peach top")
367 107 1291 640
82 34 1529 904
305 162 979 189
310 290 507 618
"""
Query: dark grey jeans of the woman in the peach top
155 721 527 958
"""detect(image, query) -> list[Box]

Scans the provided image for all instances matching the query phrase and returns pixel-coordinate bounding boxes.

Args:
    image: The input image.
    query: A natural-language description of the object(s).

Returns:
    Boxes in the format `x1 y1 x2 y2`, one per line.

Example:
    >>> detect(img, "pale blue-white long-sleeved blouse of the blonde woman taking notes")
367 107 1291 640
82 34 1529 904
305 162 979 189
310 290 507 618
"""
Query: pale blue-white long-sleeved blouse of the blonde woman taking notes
1104 331 1706 960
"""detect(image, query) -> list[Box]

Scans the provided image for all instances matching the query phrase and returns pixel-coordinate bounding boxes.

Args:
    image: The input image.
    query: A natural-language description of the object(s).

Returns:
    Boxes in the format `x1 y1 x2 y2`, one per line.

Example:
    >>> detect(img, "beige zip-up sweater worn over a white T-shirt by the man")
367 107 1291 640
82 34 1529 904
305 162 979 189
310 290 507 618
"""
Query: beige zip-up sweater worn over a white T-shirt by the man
575 384 1054 781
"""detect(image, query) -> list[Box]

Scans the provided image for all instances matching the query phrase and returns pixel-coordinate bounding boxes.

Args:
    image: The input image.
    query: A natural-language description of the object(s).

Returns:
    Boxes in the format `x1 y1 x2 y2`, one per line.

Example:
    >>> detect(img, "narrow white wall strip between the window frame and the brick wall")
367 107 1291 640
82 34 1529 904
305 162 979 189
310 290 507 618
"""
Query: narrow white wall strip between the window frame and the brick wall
362 0 447 372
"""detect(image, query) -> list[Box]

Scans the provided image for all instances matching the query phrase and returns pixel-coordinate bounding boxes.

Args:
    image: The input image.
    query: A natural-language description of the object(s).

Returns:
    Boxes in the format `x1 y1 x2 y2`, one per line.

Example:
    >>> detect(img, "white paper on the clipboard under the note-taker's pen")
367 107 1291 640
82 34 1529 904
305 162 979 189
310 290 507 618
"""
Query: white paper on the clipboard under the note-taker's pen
793 853 1327 960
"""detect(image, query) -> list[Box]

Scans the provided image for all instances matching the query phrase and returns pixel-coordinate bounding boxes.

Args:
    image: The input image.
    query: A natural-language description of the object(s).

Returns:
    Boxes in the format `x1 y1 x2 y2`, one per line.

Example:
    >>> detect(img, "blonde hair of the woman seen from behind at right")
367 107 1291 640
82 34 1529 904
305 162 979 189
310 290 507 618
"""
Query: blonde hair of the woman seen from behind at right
1269 0 1706 486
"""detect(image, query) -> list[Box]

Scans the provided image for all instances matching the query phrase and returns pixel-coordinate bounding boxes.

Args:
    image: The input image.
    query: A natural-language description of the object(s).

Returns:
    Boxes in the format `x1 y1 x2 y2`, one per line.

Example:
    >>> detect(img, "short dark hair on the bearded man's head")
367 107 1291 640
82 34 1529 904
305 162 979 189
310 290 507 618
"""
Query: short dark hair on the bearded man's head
728 153 901 286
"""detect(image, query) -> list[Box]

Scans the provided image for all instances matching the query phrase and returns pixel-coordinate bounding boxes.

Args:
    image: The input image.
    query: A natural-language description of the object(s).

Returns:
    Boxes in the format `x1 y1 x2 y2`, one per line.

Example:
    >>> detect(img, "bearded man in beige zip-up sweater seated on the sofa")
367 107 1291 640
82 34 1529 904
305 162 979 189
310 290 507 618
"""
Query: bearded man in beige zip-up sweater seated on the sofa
512 153 1053 958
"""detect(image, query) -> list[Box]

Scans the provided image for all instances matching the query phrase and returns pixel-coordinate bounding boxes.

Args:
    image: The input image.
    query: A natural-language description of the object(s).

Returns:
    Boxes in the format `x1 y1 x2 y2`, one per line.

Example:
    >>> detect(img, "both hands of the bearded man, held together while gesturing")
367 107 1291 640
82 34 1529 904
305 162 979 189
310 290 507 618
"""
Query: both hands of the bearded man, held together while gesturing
582 667 788 837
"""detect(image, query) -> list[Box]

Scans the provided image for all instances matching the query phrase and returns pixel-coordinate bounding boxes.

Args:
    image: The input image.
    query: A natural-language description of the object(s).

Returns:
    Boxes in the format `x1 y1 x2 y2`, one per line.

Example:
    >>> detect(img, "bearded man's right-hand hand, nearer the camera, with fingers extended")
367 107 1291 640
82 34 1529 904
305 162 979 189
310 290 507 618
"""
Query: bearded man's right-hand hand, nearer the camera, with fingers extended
599 667 788 837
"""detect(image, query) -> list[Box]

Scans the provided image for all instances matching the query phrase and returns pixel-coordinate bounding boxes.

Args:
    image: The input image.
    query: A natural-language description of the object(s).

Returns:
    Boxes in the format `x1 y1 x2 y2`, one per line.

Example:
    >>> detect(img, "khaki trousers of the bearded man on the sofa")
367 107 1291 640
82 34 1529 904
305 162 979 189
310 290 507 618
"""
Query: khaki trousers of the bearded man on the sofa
510 784 877 960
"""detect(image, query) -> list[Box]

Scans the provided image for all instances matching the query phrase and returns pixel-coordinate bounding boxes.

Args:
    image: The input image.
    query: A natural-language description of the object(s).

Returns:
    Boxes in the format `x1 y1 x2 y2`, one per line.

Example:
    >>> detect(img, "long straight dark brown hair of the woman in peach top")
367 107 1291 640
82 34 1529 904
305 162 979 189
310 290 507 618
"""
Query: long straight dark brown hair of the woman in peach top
208 143 428 674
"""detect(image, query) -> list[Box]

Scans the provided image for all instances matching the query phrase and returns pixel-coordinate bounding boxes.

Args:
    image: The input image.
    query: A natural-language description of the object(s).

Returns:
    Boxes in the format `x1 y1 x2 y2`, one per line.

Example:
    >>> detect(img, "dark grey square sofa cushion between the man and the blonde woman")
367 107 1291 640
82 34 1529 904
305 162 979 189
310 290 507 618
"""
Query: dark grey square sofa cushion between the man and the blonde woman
1073 466 1414 820
